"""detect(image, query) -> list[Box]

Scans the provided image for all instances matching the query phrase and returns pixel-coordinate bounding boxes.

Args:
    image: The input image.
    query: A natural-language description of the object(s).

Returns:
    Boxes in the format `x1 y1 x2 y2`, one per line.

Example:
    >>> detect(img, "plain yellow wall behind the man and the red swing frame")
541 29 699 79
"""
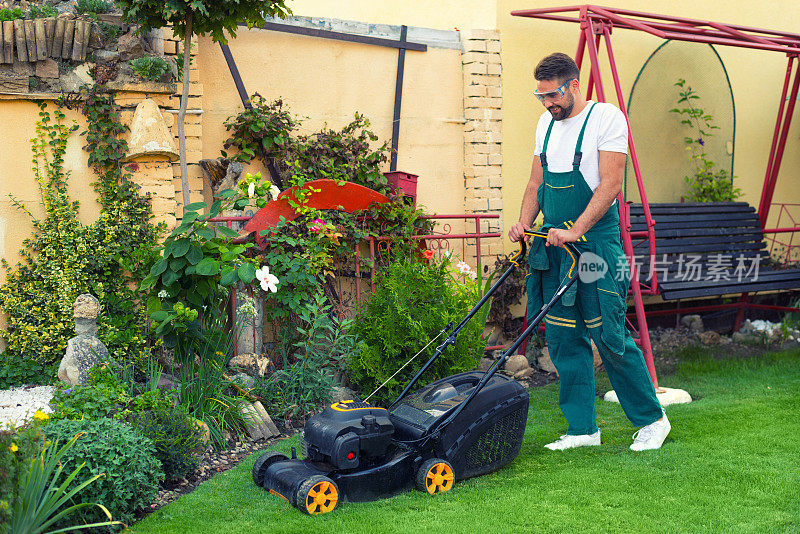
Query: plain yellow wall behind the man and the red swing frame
497 0 800 246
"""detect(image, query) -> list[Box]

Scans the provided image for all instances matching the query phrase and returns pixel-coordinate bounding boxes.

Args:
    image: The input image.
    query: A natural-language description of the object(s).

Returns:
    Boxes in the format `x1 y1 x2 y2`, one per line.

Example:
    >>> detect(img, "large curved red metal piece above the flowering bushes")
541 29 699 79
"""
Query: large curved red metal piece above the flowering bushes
244 180 389 247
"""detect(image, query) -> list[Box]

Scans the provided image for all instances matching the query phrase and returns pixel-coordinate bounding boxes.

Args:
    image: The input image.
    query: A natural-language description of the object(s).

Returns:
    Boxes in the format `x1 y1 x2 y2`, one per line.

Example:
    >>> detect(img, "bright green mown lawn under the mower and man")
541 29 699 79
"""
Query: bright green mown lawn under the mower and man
132 350 800 534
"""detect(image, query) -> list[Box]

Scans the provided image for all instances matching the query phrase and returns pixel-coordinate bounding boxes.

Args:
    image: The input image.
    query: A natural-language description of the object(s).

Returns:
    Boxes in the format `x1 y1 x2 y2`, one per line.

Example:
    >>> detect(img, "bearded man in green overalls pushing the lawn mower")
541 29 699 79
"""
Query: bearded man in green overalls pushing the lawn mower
508 53 670 451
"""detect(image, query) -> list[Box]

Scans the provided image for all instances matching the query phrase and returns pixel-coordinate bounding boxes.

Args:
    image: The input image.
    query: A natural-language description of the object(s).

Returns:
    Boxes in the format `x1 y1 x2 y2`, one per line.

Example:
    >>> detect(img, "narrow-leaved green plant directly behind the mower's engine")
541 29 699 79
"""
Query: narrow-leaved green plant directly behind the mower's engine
254 293 357 420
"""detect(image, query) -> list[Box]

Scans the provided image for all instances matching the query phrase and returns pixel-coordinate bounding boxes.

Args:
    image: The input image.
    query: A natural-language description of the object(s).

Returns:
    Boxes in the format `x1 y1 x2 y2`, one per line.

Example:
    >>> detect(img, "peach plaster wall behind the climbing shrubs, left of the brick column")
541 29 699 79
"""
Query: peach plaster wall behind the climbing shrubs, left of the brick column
199 25 464 218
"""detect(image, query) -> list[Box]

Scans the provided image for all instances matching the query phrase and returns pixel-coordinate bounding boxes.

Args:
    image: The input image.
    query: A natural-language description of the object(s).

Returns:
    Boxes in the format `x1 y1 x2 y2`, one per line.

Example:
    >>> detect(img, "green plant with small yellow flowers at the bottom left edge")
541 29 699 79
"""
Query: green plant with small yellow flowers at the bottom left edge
0 412 47 532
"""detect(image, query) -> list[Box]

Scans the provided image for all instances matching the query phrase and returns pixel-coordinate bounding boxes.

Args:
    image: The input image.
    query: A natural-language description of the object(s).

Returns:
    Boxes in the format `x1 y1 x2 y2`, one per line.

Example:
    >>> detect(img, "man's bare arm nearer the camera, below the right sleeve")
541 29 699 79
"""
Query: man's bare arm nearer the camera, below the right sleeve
548 150 627 246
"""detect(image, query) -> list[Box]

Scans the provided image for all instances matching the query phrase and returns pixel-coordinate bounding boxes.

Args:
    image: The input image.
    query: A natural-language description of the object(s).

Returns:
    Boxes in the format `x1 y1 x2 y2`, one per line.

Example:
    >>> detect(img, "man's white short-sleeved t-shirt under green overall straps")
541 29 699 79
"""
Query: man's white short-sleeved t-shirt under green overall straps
533 100 628 191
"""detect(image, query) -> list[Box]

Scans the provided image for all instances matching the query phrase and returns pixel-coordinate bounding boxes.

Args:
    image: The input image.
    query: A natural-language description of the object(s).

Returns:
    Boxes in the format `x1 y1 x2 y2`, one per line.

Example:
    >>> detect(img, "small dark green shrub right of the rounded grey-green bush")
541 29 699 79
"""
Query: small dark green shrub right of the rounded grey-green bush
128 406 201 482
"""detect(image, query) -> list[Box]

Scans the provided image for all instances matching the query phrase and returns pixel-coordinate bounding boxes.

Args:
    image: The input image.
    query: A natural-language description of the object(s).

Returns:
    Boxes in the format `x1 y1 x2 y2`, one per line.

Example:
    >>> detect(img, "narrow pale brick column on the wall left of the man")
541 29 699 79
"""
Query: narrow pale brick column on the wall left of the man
461 30 503 269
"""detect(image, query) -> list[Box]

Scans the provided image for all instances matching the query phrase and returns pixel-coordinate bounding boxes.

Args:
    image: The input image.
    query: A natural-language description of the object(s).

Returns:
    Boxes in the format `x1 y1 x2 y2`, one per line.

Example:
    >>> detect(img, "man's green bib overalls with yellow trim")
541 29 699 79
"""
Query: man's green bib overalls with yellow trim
527 104 662 435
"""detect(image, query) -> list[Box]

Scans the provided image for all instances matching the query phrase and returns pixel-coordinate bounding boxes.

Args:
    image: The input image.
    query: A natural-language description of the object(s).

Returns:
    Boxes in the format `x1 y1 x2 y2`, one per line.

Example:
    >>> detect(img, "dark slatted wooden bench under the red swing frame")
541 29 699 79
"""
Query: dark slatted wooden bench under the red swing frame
631 202 800 300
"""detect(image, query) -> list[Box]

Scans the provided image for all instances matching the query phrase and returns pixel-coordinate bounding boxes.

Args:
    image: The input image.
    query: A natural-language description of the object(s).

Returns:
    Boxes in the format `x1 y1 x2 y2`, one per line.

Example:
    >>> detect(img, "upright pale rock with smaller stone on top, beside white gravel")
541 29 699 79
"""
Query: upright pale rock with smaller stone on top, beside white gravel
58 293 108 386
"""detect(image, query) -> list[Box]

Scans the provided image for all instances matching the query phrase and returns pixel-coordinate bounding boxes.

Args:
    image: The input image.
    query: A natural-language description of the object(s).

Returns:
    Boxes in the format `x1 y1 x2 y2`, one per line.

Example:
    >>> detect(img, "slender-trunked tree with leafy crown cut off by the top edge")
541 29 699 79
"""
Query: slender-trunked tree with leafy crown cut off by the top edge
116 0 291 214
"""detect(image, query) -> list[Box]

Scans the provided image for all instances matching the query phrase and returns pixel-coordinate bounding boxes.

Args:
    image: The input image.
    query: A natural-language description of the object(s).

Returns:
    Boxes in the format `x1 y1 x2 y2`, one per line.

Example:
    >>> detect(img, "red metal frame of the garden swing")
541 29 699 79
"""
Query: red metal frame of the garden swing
511 5 800 388
